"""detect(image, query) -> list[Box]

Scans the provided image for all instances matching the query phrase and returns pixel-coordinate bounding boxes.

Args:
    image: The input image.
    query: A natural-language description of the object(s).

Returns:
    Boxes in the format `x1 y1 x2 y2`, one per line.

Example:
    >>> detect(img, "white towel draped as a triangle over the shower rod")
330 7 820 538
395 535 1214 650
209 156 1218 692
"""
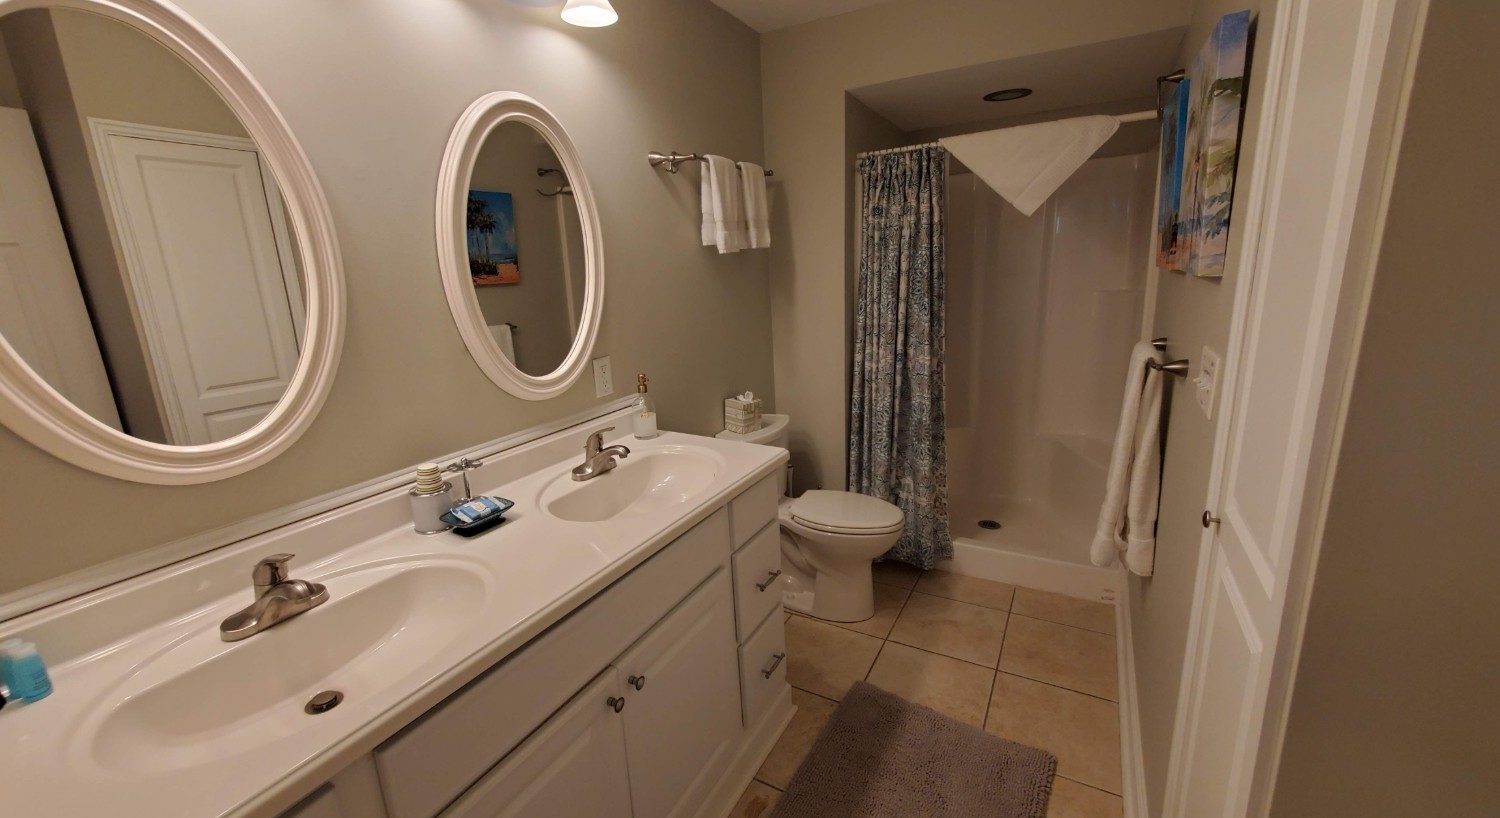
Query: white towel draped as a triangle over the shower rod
938 116 1121 216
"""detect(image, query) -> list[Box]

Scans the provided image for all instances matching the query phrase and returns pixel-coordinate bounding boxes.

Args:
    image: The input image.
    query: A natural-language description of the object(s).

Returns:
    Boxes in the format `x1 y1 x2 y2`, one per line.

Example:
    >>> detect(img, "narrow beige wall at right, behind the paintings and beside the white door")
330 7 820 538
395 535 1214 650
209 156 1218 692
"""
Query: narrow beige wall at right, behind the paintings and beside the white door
1128 0 1269 815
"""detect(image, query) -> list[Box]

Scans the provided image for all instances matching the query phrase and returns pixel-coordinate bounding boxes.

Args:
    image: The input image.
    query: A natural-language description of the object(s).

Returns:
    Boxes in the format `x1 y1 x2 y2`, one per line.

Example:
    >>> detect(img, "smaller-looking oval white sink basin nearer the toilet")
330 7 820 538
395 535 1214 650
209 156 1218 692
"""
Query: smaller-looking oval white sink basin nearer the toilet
542 446 720 522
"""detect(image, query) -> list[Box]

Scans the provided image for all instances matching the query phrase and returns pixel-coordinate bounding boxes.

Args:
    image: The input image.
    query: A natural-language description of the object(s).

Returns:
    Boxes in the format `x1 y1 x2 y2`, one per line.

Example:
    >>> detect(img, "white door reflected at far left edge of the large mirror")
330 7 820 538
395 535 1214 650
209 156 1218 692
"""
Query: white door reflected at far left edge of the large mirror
0 108 120 429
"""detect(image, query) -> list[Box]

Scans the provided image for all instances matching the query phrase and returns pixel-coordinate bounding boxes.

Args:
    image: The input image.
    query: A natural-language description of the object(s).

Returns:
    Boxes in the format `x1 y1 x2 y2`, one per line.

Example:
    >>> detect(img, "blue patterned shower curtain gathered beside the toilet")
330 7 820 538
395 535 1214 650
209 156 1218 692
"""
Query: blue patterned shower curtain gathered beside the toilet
849 146 953 569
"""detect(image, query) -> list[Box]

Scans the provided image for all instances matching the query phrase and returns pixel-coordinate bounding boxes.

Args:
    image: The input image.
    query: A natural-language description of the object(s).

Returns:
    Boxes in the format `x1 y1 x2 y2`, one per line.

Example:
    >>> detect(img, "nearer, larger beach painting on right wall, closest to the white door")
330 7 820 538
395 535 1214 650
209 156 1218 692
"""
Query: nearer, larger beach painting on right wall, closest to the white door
1176 11 1250 278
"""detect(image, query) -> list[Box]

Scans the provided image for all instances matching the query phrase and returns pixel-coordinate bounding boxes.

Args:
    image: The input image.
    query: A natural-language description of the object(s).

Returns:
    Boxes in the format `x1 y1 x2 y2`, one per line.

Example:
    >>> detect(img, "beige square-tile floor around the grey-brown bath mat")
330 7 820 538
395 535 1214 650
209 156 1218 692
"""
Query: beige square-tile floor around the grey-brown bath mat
731 563 1124 818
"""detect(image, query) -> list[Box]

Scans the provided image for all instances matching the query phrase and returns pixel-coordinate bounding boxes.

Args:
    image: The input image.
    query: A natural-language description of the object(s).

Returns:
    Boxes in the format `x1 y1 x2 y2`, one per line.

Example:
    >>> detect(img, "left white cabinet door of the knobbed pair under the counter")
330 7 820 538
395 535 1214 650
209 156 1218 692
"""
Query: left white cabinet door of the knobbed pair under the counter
443 668 633 818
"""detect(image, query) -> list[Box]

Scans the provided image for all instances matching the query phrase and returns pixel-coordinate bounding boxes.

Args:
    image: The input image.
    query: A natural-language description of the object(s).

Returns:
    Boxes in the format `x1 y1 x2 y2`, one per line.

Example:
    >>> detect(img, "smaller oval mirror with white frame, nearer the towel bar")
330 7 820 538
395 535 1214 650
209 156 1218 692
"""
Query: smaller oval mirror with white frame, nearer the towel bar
437 93 605 401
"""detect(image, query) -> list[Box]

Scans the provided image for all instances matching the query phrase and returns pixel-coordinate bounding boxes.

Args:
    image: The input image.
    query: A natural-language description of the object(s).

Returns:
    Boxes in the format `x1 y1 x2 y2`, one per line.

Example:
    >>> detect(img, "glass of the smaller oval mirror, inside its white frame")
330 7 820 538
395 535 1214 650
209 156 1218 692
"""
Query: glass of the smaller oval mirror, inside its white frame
468 122 584 375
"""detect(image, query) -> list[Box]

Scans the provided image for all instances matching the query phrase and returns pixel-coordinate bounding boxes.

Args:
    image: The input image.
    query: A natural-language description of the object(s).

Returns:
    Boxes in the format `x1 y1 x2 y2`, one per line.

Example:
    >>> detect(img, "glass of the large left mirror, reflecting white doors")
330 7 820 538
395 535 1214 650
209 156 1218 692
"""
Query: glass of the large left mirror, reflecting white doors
0 9 306 444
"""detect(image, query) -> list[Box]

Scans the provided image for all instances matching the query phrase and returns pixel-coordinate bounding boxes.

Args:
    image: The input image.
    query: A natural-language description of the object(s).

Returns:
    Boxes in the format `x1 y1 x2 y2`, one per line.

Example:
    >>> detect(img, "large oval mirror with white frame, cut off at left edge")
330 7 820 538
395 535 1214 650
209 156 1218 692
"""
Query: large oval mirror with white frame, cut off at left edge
0 0 344 483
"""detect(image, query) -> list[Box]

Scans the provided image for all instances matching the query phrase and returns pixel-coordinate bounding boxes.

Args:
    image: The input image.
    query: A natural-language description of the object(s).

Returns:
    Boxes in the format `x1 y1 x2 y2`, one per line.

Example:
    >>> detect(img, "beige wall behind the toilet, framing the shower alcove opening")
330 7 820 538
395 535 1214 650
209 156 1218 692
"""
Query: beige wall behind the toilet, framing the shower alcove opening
761 0 1191 489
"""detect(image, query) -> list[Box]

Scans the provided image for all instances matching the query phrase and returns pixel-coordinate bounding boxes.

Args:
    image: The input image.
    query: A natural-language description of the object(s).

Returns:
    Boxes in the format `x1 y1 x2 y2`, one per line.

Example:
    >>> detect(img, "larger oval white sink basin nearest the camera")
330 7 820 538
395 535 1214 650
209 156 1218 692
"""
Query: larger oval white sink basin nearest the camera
78 561 488 771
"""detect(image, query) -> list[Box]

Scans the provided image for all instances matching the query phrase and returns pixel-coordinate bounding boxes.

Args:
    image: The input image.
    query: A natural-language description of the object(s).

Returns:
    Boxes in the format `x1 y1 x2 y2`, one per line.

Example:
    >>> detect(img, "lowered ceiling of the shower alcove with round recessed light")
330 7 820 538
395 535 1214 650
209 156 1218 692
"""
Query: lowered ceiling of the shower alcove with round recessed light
858 27 1185 132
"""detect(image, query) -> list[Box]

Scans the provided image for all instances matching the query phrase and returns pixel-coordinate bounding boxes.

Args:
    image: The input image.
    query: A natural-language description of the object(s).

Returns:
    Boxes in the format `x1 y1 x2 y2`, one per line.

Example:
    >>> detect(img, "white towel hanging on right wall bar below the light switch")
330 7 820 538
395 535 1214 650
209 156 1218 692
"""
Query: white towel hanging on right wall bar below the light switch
1089 341 1163 576
